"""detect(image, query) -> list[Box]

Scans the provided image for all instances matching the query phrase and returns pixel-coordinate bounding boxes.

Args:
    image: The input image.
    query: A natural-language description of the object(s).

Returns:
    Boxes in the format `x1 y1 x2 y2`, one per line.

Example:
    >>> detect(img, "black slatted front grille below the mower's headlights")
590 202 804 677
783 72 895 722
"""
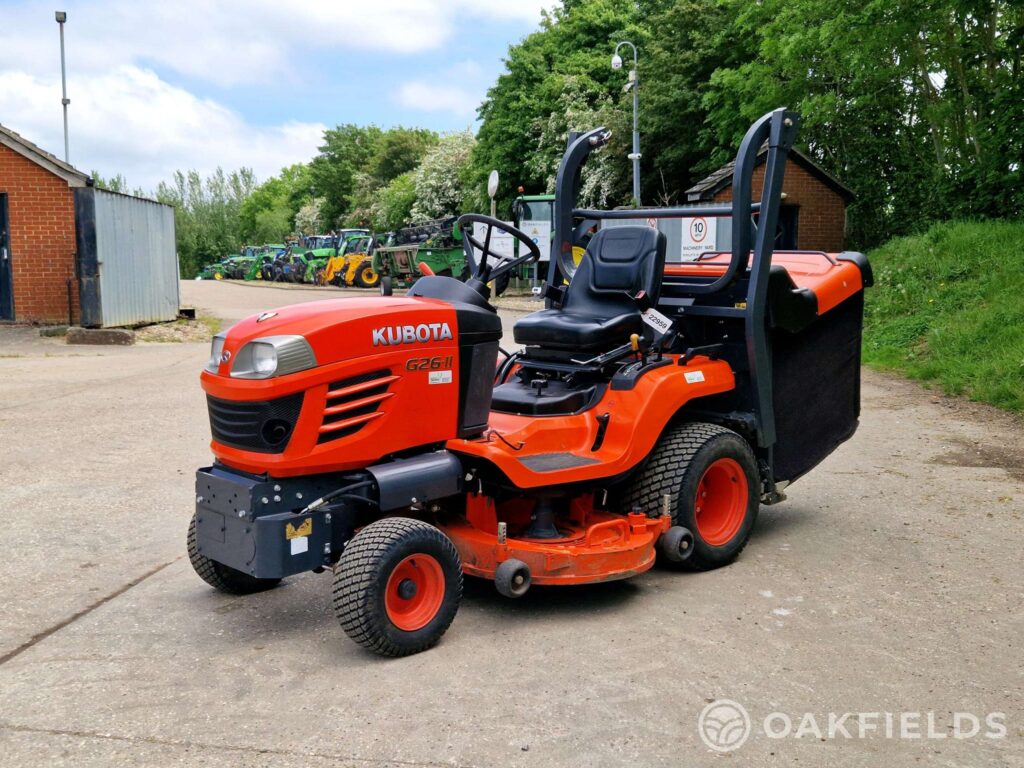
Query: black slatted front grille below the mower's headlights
206 392 303 454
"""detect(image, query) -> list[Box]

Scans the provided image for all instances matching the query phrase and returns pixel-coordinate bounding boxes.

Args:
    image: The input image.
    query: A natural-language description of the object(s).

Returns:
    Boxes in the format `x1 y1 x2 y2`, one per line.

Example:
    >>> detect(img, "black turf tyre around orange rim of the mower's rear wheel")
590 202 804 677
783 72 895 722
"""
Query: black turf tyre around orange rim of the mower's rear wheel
621 422 760 570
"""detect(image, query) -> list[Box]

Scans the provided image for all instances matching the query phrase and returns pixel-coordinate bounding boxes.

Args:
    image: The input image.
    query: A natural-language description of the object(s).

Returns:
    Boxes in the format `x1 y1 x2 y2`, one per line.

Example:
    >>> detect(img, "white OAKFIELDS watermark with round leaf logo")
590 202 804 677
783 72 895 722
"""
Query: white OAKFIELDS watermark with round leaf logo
697 698 1007 752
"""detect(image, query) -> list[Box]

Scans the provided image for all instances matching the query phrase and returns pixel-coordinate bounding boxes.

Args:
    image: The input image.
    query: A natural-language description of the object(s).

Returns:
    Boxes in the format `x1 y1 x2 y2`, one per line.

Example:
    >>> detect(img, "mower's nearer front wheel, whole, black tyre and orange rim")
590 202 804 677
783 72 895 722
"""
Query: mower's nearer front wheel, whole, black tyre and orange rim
334 517 462 656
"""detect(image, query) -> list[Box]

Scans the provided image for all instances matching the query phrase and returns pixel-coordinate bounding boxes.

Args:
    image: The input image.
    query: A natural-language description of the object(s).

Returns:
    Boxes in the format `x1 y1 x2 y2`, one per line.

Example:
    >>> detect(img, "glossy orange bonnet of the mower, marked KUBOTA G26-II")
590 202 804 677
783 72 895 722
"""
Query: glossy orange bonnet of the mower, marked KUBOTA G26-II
201 297 459 477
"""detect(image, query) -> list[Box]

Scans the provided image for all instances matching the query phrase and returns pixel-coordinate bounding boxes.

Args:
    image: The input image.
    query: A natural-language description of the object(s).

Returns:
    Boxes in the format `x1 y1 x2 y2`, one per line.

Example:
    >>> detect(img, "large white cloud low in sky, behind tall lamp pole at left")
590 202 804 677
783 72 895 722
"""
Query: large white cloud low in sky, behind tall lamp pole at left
0 67 325 190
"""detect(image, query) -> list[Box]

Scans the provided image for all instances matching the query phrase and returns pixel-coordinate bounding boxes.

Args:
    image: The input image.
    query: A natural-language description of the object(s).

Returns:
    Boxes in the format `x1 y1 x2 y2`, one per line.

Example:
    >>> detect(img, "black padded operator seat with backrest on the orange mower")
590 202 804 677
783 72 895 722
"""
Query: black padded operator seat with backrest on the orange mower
513 225 666 351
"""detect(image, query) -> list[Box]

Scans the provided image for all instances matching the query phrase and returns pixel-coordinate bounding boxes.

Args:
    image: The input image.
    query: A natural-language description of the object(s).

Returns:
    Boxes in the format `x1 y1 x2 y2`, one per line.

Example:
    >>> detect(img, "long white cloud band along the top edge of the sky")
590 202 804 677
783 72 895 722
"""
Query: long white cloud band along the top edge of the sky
0 0 552 86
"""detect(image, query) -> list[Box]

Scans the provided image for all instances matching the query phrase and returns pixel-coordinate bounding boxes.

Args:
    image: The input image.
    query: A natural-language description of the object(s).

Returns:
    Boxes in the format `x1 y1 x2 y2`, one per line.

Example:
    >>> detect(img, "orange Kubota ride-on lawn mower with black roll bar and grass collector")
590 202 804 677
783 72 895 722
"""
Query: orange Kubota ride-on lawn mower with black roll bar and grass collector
188 110 870 656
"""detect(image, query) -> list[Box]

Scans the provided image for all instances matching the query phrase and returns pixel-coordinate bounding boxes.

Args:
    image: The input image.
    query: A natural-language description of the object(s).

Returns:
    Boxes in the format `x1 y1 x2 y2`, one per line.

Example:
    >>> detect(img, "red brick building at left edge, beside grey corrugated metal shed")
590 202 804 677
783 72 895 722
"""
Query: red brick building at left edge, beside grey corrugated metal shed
0 125 89 323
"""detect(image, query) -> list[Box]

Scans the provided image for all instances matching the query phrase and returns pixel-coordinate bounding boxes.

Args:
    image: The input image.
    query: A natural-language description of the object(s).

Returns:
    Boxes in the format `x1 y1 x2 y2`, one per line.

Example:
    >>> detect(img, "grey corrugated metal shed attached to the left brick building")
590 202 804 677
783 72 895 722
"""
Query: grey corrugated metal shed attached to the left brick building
75 187 179 328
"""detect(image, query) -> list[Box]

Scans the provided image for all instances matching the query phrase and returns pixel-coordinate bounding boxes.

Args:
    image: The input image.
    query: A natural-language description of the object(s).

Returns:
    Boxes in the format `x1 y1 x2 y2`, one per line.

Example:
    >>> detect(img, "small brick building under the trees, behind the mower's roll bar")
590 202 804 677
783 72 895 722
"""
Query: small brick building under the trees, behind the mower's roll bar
686 150 854 253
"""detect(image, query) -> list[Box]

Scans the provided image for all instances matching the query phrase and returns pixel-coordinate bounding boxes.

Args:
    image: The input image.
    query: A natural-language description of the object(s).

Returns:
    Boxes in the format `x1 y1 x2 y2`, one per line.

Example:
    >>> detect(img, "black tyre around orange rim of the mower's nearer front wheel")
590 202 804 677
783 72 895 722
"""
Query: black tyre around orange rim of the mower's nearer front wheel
333 517 462 656
